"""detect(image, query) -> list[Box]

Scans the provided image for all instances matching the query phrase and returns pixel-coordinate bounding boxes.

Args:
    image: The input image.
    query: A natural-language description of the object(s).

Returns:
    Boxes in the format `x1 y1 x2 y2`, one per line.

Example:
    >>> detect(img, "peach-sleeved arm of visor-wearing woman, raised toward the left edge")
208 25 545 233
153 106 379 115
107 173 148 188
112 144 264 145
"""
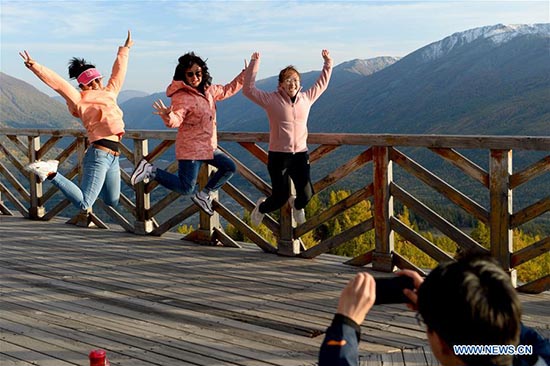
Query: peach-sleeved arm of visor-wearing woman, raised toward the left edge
19 50 80 109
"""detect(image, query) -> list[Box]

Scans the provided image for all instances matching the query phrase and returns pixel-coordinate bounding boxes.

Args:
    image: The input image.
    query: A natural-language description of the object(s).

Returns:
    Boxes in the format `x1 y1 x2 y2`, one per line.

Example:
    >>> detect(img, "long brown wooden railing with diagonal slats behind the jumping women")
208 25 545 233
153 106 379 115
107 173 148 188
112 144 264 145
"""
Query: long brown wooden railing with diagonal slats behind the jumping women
0 128 550 292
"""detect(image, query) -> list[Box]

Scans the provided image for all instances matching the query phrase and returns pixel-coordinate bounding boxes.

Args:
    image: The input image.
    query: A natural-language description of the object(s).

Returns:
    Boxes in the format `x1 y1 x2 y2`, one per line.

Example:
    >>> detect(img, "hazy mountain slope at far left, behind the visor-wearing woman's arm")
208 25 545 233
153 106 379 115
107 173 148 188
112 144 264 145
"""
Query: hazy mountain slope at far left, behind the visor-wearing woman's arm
0 72 82 128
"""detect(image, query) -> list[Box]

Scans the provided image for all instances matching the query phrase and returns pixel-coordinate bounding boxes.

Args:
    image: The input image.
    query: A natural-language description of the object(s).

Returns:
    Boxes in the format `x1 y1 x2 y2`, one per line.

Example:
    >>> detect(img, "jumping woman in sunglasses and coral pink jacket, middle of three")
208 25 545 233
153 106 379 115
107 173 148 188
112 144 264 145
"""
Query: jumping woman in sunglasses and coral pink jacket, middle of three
131 52 246 215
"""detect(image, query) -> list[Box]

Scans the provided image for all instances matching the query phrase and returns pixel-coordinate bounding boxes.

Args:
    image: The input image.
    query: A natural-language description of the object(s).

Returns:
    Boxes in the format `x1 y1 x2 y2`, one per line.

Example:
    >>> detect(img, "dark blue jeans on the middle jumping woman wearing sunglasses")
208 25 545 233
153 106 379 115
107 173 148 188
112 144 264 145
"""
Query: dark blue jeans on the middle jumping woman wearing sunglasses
155 149 237 196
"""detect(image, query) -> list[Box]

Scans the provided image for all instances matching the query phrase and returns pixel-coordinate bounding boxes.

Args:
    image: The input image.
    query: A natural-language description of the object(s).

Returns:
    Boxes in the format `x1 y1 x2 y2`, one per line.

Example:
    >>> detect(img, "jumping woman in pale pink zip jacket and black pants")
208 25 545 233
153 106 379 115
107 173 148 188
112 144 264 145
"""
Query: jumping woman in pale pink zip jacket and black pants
243 50 332 226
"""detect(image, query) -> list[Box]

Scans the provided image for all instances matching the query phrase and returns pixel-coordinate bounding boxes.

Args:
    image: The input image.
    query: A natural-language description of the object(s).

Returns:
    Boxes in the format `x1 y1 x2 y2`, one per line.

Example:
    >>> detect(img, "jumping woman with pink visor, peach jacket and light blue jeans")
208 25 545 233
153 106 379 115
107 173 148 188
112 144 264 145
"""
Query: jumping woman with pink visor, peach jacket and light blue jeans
19 31 134 210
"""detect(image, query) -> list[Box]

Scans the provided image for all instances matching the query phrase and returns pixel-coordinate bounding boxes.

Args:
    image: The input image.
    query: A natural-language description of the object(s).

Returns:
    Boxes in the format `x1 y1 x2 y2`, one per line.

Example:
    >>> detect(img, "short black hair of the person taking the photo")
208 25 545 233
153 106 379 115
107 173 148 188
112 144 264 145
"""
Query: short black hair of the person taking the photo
418 253 521 366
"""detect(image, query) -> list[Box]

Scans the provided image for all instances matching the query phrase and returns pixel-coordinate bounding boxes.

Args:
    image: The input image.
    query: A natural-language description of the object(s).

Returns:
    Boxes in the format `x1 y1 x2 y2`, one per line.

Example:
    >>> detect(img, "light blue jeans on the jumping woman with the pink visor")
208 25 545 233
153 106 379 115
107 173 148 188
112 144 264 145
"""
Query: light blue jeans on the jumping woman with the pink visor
52 147 120 210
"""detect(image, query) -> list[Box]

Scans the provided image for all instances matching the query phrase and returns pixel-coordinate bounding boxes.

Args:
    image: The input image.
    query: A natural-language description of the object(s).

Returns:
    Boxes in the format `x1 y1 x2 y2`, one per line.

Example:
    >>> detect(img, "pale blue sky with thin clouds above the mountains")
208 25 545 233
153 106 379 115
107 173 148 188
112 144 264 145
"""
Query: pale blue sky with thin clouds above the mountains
0 0 550 95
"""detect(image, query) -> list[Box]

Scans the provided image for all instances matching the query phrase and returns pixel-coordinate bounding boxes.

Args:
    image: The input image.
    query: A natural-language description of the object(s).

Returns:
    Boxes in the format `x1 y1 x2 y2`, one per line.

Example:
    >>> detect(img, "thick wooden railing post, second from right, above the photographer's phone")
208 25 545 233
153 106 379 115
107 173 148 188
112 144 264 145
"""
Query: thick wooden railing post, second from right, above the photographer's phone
372 146 394 272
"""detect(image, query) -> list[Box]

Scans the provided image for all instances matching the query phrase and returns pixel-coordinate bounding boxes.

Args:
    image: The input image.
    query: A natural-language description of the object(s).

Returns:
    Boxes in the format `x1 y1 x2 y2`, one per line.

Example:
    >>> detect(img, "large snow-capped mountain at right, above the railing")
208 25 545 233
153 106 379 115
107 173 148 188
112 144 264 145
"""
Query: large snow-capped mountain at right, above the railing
310 24 550 135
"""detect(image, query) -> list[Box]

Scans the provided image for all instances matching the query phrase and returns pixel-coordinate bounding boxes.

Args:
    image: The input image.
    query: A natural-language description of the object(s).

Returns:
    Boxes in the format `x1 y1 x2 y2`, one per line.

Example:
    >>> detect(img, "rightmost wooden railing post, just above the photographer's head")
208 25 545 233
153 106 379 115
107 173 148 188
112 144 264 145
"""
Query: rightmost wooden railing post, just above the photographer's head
489 150 517 286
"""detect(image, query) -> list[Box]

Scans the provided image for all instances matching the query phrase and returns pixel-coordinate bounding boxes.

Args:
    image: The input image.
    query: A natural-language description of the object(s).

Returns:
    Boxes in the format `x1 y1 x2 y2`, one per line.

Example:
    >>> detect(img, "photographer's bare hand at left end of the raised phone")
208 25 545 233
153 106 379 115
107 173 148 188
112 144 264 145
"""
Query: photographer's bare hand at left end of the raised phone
336 272 376 325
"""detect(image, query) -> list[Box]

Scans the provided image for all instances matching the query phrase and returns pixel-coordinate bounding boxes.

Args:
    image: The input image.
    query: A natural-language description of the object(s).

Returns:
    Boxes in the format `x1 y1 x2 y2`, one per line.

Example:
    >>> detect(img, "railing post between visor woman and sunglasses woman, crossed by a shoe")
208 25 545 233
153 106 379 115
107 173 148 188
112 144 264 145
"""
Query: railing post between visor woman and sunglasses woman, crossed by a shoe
134 139 154 235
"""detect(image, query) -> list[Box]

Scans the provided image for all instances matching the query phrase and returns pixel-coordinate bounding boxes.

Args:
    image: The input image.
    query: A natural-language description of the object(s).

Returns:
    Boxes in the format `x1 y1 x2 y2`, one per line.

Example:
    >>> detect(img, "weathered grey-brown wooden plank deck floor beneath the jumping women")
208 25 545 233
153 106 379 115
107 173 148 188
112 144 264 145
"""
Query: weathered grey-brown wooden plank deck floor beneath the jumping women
0 215 550 366
